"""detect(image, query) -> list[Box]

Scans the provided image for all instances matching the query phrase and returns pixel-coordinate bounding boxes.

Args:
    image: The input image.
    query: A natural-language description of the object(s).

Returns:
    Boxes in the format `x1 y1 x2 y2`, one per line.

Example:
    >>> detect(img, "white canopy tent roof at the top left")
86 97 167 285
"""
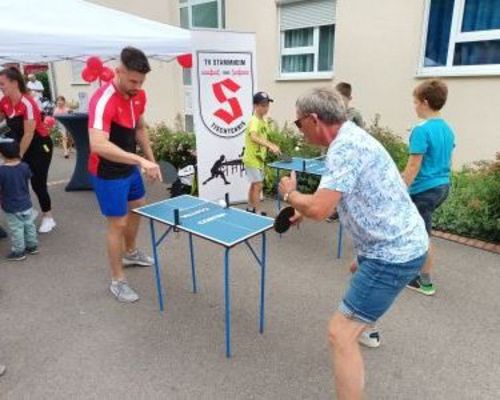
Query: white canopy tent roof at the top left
0 0 191 64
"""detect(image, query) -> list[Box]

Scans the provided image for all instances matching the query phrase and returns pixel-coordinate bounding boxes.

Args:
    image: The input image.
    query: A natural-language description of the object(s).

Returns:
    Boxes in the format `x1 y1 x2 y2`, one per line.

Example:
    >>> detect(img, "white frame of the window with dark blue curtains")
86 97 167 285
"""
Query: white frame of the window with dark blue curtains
417 0 500 78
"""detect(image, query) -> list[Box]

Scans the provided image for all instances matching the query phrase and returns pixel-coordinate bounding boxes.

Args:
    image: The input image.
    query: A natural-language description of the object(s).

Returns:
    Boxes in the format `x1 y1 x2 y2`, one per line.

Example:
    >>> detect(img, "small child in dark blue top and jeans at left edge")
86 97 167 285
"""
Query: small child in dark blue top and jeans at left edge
0 141 38 261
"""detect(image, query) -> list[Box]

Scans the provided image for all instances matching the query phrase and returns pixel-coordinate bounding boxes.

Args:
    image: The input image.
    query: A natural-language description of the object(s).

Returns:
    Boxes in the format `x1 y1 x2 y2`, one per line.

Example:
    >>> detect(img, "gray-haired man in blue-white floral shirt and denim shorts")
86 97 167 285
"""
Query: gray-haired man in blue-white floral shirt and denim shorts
279 89 429 400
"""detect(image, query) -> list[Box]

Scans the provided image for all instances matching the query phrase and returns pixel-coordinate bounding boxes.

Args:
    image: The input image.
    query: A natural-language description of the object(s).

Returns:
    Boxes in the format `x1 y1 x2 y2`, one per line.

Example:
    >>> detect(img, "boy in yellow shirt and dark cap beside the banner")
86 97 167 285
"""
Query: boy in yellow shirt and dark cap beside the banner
243 92 280 213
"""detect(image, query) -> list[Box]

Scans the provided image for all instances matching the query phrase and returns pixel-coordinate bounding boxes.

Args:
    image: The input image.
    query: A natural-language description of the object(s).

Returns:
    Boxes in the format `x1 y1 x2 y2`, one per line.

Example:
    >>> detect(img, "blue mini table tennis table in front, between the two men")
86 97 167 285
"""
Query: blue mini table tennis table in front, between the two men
133 195 274 357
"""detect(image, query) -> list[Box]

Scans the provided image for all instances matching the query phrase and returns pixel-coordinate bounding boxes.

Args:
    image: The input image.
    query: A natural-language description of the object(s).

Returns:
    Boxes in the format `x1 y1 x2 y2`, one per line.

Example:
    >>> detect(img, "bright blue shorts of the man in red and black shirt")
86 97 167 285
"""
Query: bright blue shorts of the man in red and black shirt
92 167 146 217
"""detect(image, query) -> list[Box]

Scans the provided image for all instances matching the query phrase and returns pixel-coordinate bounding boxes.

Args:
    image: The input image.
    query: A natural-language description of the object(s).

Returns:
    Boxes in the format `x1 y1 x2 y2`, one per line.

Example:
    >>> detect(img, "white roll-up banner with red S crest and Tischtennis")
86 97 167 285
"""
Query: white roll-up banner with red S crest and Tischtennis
193 31 256 202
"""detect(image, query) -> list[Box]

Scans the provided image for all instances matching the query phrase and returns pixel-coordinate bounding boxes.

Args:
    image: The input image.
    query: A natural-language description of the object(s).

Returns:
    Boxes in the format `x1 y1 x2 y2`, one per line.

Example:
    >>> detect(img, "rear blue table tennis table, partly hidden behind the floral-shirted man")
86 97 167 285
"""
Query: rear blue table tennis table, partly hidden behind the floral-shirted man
268 156 342 258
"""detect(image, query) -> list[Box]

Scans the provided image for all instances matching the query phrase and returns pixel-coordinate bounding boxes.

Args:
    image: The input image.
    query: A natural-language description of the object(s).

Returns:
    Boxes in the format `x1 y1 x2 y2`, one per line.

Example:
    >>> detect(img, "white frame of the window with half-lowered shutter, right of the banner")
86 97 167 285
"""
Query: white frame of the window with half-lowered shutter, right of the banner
276 24 336 80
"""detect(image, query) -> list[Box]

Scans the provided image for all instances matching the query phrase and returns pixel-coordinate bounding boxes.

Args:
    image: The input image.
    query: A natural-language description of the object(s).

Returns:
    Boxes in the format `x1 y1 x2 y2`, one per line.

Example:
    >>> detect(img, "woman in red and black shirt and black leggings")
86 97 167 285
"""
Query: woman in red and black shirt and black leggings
0 67 56 233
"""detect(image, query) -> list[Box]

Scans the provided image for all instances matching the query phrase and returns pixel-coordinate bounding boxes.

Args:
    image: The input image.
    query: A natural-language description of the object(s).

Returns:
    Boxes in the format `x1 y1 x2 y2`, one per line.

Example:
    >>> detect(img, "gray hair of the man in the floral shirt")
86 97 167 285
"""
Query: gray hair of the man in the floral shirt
295 88 347 125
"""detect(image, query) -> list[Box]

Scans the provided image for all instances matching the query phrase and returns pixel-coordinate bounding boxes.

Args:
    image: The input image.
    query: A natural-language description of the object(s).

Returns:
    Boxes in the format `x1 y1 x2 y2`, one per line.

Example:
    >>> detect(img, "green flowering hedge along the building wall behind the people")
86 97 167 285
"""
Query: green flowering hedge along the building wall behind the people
151 119 500 242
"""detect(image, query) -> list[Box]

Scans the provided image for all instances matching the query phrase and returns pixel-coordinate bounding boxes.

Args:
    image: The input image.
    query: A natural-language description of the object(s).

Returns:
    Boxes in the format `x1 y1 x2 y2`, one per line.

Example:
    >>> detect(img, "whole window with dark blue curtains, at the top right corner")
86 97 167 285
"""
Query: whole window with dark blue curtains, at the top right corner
419 0 500 76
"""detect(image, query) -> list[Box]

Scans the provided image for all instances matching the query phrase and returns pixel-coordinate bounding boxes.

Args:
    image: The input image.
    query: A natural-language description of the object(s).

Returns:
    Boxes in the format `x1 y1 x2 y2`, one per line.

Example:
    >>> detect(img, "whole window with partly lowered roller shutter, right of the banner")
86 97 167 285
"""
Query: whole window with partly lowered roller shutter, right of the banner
278 0 336 79
